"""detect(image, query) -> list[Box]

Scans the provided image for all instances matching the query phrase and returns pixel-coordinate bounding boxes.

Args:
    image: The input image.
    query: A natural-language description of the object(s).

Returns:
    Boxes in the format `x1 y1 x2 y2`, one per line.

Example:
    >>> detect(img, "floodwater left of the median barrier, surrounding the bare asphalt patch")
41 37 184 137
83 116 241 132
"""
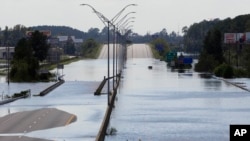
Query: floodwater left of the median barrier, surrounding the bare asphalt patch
0 59 107 141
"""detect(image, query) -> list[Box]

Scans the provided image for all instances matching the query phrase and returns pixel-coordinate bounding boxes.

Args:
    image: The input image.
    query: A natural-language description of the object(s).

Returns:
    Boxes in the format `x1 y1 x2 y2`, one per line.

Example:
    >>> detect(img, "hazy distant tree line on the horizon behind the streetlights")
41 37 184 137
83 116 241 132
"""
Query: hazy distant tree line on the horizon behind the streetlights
0 25 182 46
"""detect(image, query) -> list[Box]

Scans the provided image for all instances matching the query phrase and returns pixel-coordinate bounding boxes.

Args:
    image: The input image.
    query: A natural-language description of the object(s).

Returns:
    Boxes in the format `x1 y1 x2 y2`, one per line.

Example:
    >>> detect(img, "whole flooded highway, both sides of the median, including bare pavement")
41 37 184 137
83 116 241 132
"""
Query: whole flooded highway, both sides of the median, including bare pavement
0 44 250 141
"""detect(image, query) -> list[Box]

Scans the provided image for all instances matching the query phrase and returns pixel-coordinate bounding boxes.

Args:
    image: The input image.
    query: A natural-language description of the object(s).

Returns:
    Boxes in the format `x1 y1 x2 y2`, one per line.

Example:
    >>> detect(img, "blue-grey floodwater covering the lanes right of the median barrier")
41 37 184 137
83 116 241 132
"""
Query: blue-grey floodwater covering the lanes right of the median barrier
105 58 250 141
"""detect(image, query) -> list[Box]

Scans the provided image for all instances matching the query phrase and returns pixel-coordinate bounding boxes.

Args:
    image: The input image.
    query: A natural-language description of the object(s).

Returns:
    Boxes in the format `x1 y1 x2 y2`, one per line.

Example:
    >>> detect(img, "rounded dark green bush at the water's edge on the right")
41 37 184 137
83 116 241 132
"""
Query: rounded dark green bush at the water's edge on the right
214 63 234 78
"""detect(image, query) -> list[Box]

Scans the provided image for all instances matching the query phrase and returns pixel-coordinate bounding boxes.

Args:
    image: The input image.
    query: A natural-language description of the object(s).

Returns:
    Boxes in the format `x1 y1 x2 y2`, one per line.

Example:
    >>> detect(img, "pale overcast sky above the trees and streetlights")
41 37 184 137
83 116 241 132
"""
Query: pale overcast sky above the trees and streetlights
0 0 250 35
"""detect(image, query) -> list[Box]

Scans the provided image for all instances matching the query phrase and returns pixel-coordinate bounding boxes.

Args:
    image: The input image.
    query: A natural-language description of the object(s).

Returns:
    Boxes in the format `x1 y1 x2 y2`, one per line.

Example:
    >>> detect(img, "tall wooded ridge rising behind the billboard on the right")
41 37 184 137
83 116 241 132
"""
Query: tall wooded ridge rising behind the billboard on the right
182 14 250 52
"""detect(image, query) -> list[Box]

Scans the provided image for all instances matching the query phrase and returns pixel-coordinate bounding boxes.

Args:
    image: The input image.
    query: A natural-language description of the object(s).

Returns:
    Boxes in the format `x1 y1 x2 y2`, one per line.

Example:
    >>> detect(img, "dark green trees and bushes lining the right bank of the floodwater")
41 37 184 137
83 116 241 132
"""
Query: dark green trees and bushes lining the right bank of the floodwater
191 15 250 78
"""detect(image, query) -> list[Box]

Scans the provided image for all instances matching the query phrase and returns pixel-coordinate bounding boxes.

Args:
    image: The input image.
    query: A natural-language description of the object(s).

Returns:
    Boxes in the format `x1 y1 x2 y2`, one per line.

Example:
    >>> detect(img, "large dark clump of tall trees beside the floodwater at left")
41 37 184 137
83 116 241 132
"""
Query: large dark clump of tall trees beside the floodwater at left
10 31 49 82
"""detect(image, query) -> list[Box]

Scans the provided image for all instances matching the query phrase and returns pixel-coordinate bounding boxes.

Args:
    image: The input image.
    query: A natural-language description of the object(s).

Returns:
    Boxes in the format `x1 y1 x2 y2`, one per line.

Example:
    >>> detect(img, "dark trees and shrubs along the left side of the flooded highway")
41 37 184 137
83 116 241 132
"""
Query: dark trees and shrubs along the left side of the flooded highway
0 25 101 82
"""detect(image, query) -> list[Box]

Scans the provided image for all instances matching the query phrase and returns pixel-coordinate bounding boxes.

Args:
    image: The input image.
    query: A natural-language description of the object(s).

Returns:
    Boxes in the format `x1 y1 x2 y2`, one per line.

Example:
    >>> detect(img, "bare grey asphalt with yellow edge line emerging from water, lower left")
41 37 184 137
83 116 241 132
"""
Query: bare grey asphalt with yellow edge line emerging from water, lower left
0 108 76 141
